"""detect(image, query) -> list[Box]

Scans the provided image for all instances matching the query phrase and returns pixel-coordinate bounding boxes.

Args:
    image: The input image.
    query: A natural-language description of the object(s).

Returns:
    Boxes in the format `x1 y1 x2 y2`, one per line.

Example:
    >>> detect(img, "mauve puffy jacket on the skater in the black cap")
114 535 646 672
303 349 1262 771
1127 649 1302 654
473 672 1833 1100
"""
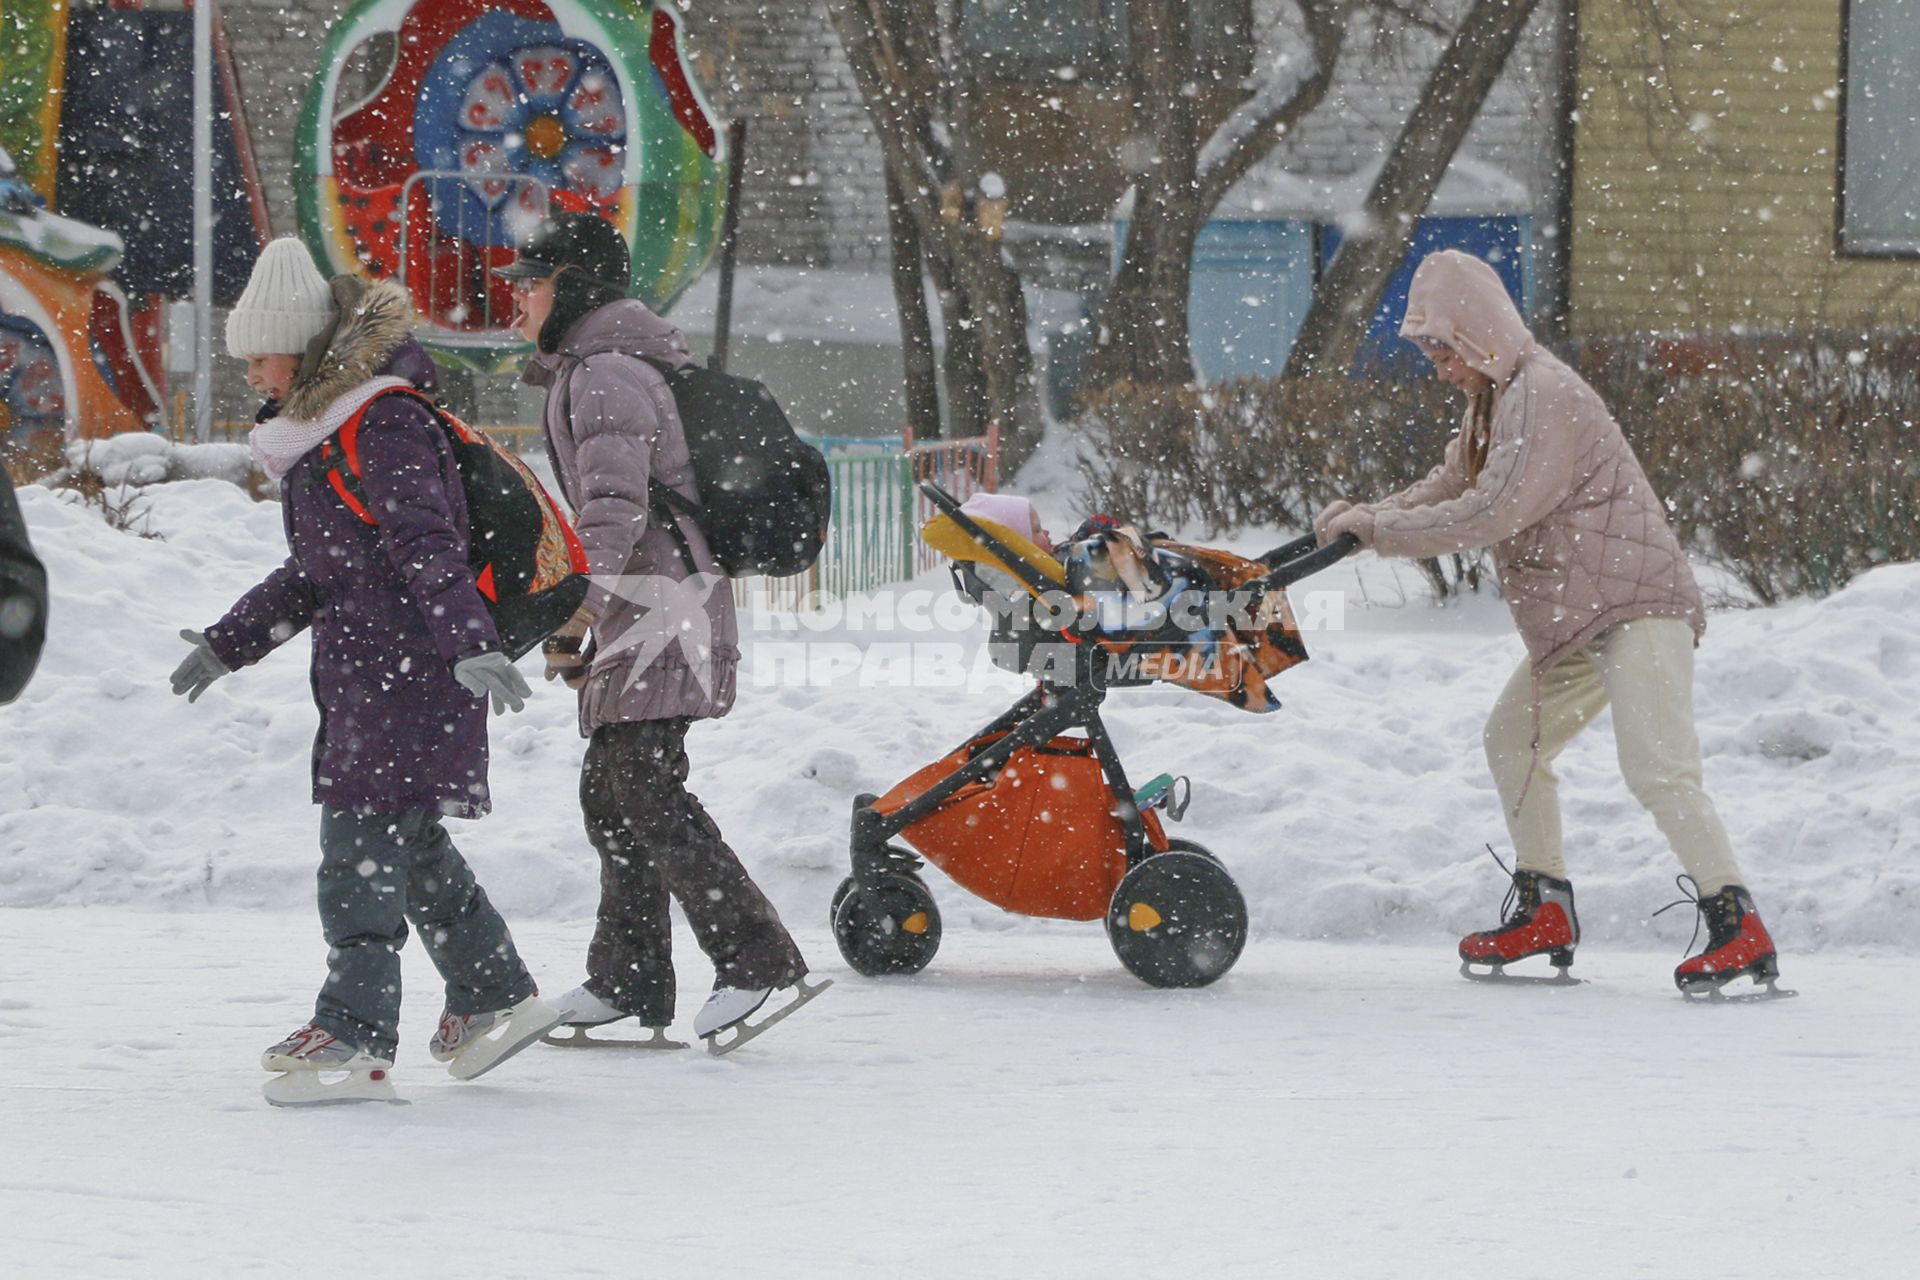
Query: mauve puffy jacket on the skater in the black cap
522 299 739 737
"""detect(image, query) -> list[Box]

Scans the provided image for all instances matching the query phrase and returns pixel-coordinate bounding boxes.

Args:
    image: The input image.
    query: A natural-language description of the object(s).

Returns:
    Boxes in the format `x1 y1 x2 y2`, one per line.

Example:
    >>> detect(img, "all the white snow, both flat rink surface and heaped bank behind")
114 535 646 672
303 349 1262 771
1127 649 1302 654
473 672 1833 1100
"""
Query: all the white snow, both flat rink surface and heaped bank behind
0 478 1920 1280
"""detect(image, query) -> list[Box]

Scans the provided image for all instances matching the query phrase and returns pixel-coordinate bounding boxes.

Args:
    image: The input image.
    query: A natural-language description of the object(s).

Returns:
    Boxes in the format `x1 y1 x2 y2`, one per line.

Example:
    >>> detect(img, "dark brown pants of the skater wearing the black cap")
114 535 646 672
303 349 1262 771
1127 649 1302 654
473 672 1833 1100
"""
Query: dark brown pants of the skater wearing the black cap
580 720 806 1027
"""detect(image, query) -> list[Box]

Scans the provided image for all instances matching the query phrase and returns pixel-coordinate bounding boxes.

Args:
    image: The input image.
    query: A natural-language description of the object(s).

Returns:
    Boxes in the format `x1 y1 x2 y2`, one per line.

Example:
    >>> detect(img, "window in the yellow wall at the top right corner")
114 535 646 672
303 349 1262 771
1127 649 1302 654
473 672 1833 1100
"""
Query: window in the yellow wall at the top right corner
1839 0 1920 255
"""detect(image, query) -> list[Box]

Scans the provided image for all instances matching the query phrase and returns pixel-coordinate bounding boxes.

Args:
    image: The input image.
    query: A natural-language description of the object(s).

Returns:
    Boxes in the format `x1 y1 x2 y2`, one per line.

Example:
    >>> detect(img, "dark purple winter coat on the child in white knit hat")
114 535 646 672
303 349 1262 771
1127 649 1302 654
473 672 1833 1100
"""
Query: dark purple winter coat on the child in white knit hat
207 320 499 818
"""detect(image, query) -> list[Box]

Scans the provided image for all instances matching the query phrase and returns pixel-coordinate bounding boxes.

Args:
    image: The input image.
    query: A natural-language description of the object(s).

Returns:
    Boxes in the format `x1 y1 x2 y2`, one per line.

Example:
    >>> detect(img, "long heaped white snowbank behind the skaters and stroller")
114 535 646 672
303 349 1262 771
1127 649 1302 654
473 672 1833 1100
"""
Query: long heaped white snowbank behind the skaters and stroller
0 485 1920 952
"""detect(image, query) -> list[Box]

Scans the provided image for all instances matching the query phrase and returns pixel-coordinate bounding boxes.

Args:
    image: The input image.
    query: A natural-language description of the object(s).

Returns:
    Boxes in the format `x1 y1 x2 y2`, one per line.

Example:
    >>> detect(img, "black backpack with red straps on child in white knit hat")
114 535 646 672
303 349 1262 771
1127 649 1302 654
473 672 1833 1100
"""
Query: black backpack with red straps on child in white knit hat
321 388 588 658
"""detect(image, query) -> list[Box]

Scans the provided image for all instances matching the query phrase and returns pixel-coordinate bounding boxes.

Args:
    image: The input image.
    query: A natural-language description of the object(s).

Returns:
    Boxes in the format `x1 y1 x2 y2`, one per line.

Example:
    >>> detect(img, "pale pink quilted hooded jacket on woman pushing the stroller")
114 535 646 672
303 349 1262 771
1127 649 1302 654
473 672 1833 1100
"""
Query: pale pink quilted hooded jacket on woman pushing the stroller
1373 249 1707 674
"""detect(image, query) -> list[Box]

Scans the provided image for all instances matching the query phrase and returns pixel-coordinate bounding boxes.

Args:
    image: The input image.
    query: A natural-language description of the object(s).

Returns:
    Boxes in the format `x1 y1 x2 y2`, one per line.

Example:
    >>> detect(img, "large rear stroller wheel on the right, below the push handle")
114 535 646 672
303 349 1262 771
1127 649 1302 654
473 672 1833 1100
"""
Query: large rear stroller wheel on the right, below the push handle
1106 841 1246 986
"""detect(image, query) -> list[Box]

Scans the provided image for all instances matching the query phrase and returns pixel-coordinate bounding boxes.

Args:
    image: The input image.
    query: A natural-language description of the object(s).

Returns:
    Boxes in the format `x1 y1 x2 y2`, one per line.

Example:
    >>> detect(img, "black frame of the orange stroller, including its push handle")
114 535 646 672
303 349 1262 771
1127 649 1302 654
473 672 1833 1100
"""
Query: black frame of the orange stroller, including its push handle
831 482 1359 986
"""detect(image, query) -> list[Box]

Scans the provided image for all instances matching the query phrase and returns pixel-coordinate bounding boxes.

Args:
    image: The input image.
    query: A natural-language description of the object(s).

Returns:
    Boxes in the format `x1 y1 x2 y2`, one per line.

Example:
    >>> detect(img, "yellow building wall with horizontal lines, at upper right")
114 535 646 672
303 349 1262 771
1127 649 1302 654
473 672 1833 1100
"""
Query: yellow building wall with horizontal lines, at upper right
1572 0 1920 334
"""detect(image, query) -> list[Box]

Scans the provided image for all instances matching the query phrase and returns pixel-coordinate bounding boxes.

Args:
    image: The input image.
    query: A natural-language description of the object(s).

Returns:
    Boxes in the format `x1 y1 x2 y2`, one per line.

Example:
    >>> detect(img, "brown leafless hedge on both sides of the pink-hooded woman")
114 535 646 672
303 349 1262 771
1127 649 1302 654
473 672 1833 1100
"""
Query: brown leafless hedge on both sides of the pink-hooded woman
1079 332 1920 604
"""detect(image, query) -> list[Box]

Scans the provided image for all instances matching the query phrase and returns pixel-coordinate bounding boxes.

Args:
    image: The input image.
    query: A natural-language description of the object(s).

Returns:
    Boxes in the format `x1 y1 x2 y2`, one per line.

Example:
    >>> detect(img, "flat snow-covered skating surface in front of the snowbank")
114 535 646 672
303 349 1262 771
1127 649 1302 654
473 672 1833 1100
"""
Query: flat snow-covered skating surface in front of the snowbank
0 908 1920 1280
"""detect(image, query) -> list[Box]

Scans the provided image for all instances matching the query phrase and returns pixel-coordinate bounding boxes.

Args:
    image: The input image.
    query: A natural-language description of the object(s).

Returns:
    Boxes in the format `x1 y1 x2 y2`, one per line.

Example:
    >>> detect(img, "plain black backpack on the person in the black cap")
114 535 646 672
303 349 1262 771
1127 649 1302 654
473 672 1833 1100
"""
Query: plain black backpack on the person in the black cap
614 357 833 578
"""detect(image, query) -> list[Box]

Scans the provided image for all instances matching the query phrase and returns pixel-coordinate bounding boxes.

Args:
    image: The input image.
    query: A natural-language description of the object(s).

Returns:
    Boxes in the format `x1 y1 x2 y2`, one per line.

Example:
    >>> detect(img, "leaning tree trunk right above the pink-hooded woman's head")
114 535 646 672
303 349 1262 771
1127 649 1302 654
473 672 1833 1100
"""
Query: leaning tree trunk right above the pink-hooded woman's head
1286 0 1538 378
